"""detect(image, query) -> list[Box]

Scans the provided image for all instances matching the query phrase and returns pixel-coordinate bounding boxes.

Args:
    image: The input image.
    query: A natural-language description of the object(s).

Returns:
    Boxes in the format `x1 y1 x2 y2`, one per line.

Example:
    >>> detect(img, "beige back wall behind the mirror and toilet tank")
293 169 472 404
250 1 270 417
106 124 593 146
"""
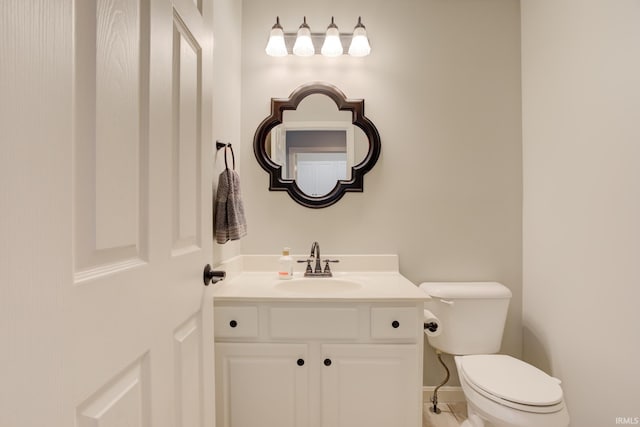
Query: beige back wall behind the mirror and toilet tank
238 0 522 385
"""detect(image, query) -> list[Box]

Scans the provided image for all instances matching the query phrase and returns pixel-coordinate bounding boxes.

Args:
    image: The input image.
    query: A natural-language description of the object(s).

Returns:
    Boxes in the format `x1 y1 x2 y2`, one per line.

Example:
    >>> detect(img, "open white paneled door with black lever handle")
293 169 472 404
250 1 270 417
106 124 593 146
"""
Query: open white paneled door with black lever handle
0 0 214 427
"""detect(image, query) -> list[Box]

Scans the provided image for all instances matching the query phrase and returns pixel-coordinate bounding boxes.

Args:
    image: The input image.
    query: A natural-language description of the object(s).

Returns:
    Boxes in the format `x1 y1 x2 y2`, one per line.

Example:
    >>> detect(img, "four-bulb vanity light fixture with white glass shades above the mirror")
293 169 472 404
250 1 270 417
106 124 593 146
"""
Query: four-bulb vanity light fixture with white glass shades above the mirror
265 16 371 57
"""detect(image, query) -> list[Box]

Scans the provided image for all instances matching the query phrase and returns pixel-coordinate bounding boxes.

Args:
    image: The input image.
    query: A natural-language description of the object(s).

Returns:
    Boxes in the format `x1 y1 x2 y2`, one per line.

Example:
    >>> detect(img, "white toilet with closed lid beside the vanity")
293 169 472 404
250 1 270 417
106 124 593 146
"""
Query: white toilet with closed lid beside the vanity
420 282 569 427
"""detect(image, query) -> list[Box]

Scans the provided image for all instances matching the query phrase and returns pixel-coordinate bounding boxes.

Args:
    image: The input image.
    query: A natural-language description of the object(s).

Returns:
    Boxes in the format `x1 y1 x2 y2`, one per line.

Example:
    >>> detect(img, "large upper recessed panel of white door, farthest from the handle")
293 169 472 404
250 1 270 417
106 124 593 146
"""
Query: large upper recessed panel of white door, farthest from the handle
73 0 150 283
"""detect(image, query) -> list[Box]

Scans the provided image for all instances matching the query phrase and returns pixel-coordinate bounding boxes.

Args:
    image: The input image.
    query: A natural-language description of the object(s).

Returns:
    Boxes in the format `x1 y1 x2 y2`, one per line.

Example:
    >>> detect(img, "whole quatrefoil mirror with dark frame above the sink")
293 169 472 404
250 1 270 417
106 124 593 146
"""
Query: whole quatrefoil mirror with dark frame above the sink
253 83 380 208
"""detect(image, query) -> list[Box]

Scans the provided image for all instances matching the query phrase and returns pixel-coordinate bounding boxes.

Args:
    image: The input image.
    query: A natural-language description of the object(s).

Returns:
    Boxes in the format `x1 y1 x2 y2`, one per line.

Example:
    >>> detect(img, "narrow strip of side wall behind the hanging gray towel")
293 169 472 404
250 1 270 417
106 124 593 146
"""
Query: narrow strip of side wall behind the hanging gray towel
212 0 242 265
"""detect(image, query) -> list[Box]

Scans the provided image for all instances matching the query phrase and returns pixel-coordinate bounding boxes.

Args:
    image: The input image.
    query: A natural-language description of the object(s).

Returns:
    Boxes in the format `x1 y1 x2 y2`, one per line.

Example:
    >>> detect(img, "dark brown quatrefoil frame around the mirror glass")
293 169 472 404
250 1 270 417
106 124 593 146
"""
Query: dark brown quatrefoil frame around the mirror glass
253 82 381 208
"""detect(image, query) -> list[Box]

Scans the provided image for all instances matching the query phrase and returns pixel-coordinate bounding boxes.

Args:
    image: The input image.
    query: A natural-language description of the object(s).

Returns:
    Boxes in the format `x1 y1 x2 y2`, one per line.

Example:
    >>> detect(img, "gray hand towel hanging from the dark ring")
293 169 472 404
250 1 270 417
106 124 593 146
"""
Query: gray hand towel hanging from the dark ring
213 169 247 243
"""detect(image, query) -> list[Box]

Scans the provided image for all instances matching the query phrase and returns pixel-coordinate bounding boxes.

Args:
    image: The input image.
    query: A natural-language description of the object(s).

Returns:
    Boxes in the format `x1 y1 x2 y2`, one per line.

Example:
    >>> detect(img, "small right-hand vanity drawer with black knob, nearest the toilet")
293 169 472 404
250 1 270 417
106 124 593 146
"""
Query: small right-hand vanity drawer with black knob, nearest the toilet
371 307 418 341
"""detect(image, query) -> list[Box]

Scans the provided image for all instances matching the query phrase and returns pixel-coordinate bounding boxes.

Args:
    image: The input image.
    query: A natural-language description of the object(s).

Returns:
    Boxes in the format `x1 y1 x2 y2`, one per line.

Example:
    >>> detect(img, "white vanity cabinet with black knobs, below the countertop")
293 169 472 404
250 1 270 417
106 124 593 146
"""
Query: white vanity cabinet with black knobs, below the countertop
214 301 423 427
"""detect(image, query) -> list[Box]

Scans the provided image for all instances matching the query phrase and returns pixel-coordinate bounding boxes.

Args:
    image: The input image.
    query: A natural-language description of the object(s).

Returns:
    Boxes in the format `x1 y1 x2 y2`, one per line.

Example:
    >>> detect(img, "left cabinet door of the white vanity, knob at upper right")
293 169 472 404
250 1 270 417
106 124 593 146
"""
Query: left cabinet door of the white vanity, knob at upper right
215 343 309 427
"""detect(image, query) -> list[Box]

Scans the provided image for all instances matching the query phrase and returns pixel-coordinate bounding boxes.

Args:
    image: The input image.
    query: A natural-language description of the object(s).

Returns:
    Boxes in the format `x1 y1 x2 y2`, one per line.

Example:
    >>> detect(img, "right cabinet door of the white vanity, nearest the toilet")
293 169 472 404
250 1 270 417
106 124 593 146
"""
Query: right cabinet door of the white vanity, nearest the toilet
321 344 422 427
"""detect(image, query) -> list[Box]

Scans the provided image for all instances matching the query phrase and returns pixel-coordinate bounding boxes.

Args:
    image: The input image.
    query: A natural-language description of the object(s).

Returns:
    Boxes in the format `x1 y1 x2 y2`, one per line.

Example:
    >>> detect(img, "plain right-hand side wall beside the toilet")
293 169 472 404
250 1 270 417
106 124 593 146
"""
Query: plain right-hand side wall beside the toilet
522 0 640 427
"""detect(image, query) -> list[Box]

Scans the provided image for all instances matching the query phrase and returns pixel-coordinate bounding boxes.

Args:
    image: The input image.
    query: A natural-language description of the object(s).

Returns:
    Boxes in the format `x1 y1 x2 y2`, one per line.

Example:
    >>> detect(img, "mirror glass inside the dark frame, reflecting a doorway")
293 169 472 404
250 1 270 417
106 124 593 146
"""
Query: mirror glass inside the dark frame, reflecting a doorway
266 94 369 196
